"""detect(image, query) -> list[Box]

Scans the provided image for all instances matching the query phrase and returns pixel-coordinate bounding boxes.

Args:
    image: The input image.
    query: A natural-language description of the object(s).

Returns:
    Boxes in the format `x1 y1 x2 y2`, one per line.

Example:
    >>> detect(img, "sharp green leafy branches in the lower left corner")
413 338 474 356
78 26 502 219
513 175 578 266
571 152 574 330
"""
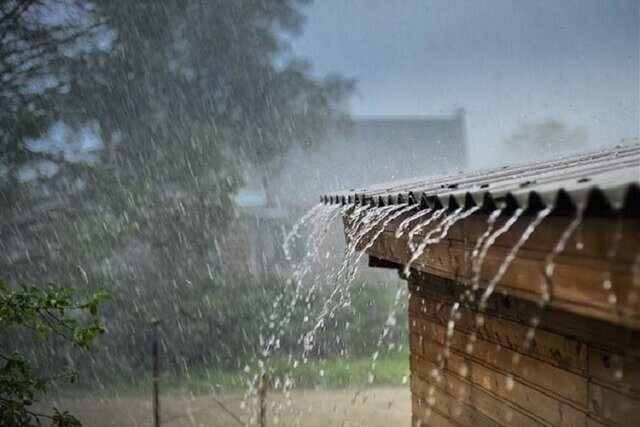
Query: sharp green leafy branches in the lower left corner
0 280 109 426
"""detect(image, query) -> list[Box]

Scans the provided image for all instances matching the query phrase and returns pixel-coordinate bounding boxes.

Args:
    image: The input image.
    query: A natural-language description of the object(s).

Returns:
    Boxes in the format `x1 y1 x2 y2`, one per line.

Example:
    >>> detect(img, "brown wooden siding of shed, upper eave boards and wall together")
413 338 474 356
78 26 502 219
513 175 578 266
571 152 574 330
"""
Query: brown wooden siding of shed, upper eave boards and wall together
346 206 640 426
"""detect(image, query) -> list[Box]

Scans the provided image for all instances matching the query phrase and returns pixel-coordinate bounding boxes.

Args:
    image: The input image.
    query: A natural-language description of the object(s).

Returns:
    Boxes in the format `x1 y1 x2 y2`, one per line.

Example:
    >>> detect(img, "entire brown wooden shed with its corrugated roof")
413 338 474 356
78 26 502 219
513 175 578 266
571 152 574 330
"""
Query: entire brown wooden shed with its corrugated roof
322 145 640 426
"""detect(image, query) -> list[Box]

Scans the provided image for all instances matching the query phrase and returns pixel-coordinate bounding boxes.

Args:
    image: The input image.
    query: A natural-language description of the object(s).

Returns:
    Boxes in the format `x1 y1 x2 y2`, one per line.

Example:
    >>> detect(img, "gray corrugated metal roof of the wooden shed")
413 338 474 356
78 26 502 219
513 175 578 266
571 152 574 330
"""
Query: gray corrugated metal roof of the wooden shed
321 139 640 216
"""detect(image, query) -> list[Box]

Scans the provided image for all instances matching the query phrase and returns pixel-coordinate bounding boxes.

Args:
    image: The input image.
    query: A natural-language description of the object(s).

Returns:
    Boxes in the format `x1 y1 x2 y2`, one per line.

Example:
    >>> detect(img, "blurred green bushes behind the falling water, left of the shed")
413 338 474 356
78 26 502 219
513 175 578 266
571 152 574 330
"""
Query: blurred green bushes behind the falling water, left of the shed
153 276 406 370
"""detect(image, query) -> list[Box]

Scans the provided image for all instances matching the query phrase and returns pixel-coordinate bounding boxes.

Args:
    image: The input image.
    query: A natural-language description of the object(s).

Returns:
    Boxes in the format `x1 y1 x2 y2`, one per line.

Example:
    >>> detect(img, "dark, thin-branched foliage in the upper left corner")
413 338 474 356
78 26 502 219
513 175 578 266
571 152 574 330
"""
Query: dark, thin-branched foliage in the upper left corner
0 0 106 172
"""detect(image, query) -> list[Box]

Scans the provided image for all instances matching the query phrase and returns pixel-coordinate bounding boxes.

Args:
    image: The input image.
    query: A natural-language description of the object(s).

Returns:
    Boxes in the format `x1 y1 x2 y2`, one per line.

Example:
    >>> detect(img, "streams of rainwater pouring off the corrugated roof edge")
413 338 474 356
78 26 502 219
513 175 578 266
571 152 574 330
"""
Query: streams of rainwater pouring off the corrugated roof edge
268 204 608 424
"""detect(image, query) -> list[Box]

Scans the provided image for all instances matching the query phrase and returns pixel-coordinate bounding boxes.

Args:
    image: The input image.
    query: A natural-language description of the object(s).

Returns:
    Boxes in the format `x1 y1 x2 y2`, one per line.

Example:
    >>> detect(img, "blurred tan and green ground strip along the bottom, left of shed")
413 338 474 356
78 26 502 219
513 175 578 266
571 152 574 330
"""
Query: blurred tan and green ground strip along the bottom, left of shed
45 352 411 427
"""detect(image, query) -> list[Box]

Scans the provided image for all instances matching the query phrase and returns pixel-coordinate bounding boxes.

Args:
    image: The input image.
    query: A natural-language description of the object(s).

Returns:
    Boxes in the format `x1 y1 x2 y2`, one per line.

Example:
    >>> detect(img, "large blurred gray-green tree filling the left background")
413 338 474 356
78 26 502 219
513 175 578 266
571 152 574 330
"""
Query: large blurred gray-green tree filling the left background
0 0 353 317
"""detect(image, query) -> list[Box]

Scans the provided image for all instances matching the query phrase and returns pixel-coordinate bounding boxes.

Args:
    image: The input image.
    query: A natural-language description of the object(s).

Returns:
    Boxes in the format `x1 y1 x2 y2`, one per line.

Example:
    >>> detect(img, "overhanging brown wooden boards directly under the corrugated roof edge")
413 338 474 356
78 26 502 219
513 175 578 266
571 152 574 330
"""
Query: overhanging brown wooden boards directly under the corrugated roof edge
362 215 640 329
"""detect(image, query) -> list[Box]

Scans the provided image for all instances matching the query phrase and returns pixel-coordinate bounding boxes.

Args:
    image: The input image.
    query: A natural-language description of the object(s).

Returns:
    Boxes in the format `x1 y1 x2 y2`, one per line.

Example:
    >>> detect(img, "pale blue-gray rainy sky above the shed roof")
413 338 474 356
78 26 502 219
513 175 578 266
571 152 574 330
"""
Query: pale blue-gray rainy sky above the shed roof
293 0 640 164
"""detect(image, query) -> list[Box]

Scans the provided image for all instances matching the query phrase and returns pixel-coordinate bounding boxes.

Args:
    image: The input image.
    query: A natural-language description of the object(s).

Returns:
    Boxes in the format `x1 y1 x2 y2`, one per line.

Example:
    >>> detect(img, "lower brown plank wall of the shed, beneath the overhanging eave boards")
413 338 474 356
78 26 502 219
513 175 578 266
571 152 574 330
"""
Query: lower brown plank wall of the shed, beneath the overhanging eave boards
409 271 640 426
